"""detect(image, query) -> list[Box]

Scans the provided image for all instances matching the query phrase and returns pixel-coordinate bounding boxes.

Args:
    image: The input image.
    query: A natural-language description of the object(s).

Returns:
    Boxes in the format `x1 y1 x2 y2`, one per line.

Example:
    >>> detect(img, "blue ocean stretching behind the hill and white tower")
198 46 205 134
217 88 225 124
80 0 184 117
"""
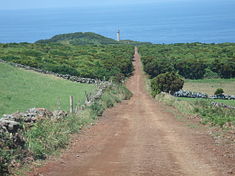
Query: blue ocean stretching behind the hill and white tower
0 0 235 44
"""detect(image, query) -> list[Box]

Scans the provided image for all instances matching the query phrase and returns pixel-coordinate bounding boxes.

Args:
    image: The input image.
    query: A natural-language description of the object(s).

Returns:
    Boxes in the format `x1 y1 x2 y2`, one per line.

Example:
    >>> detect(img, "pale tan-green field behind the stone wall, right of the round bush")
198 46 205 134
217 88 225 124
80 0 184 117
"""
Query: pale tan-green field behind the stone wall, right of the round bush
183 78 235 95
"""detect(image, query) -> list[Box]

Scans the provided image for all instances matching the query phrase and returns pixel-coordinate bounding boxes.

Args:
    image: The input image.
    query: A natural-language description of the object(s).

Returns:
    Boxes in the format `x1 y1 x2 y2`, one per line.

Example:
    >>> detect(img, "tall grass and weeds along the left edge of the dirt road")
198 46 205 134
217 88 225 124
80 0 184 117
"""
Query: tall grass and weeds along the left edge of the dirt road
13 85 132 176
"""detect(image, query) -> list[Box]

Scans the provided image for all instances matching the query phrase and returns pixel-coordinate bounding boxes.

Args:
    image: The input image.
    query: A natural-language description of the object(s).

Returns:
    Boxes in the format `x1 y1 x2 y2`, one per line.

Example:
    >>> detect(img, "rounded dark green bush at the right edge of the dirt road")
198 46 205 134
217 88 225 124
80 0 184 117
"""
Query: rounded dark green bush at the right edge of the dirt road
151 72 184 96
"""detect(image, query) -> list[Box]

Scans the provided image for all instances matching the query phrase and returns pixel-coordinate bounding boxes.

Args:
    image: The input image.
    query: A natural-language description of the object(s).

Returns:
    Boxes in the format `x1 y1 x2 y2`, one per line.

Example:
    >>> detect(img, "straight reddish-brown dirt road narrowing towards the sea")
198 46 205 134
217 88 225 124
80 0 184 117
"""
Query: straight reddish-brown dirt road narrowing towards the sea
29 49 234 176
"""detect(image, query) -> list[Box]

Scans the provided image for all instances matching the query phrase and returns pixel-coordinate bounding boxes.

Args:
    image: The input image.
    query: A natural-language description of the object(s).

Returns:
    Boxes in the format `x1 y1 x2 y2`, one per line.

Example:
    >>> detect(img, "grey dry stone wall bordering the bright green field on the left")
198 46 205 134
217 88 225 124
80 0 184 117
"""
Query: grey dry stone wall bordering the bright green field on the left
0 59 112 134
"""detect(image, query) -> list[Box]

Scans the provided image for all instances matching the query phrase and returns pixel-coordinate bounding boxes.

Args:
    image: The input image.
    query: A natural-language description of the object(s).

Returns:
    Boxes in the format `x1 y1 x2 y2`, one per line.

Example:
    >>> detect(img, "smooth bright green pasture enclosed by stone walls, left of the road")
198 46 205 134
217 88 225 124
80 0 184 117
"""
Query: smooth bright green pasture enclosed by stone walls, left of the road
0 63 95 116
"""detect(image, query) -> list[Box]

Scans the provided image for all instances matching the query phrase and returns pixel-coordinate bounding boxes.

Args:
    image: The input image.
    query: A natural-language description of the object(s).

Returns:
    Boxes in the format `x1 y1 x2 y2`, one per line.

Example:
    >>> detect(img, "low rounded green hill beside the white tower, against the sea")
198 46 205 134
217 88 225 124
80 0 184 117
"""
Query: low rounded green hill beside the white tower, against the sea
36 32 118 45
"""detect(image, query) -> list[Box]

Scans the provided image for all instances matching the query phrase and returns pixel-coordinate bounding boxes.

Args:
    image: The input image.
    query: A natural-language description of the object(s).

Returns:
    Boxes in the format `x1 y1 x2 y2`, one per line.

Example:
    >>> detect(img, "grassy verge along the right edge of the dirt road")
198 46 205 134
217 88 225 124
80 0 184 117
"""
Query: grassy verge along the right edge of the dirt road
155 93 235 129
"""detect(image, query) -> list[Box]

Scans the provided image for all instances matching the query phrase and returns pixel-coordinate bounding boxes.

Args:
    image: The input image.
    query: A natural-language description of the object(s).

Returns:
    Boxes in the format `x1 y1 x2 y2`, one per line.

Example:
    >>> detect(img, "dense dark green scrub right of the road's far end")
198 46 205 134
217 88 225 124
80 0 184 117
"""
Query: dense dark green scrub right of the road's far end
139 43 235 79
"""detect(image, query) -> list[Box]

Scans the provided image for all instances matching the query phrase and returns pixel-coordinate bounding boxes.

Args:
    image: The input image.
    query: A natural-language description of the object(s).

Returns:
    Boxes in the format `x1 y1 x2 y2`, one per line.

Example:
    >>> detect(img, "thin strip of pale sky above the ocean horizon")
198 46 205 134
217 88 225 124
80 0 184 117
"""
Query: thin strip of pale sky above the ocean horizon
0 0 191 10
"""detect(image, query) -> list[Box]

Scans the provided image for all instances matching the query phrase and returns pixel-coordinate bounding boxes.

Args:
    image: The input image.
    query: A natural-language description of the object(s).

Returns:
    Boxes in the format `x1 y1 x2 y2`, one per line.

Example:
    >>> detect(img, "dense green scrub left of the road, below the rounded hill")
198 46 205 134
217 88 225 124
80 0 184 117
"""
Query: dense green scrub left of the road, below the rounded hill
0 43 134 79
